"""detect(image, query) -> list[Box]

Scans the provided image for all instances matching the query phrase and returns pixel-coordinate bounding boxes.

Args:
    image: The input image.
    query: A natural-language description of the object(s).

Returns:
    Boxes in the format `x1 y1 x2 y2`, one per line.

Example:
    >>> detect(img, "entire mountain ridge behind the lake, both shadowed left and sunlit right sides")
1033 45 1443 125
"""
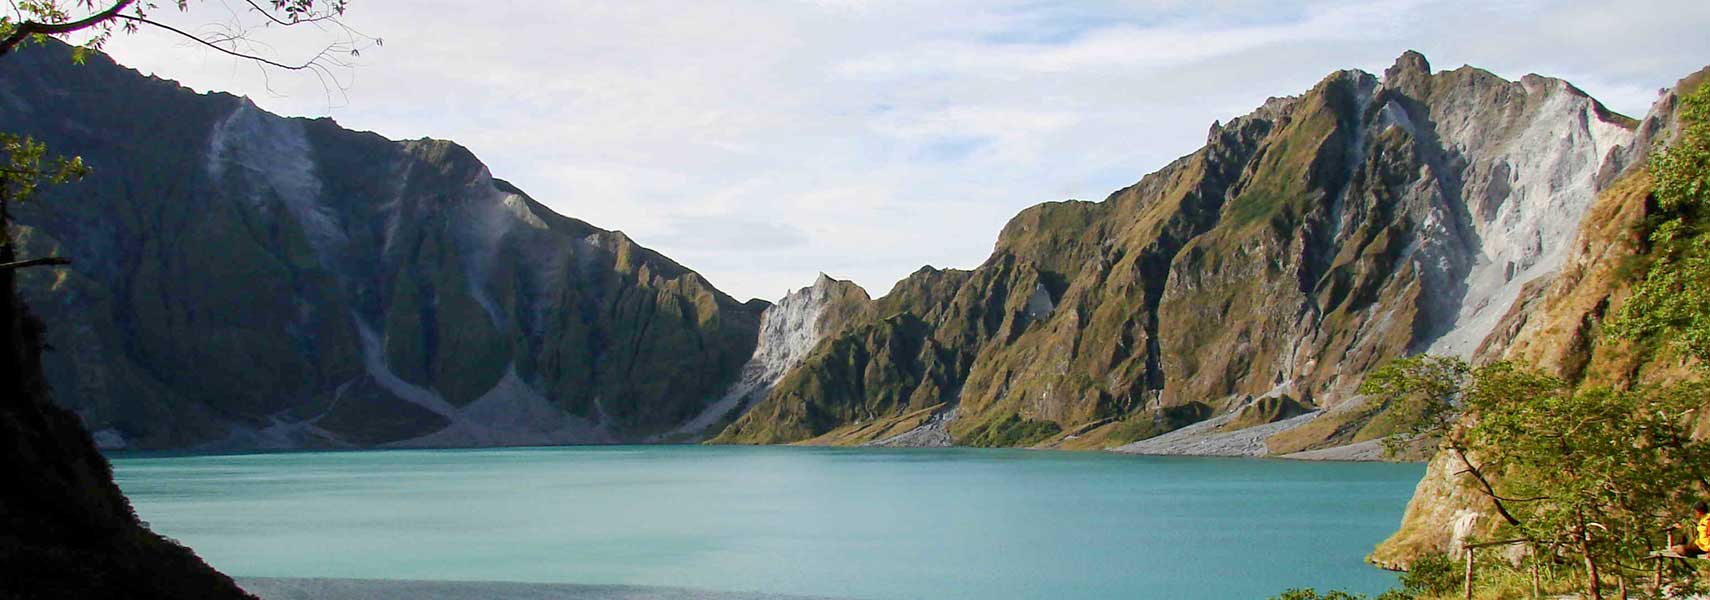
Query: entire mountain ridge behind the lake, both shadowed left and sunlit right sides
0 42 1682 455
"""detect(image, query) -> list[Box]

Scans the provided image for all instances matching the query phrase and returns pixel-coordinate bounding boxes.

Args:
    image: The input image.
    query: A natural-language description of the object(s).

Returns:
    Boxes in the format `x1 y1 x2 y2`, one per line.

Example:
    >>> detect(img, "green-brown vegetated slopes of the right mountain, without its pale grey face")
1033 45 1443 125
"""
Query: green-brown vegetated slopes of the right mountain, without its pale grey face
718 53 1573 450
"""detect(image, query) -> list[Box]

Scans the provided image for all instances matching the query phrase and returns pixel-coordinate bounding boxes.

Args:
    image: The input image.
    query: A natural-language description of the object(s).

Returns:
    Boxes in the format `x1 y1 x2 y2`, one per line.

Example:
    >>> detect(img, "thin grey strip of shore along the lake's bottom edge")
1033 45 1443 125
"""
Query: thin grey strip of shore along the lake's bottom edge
238 578 851 600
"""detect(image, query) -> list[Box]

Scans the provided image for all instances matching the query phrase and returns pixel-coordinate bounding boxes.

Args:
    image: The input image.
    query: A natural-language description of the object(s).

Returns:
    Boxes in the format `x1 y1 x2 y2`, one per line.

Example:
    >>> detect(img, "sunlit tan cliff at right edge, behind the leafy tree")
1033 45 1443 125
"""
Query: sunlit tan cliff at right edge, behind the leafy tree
1371 68 1710 568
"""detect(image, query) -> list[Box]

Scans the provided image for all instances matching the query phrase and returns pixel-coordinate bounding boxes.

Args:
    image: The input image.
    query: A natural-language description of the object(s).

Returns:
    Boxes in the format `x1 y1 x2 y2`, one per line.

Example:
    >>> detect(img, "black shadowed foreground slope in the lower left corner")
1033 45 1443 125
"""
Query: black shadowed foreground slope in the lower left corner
0 250 250 600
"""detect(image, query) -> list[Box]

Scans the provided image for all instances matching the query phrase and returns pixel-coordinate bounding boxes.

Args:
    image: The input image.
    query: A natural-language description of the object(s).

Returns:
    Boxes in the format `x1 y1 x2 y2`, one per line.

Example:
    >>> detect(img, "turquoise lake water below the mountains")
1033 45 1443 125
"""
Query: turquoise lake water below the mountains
113 446 1424 600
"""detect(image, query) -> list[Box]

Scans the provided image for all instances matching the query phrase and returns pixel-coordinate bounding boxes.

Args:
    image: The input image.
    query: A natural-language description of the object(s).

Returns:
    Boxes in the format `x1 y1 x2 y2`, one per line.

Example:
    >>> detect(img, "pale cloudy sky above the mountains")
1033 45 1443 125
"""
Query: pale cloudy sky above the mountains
90 0 1710 299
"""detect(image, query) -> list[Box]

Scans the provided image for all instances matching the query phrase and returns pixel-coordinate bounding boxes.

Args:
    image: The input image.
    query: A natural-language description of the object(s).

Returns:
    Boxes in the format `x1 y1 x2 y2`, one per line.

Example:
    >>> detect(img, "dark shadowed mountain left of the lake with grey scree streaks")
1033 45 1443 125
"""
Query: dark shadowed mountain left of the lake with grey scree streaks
0 44 764 448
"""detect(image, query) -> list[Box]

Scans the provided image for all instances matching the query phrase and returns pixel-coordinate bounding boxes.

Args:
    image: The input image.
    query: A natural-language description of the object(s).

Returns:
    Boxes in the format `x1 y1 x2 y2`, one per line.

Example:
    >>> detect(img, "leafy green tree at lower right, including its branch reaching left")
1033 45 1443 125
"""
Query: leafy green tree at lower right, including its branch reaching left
1363 356 1710 598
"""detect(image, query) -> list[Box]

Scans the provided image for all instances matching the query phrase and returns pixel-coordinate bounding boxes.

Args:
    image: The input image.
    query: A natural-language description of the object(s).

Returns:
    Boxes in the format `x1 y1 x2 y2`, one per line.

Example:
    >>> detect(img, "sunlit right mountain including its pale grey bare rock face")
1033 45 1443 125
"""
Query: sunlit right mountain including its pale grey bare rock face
723 53 1633 451
